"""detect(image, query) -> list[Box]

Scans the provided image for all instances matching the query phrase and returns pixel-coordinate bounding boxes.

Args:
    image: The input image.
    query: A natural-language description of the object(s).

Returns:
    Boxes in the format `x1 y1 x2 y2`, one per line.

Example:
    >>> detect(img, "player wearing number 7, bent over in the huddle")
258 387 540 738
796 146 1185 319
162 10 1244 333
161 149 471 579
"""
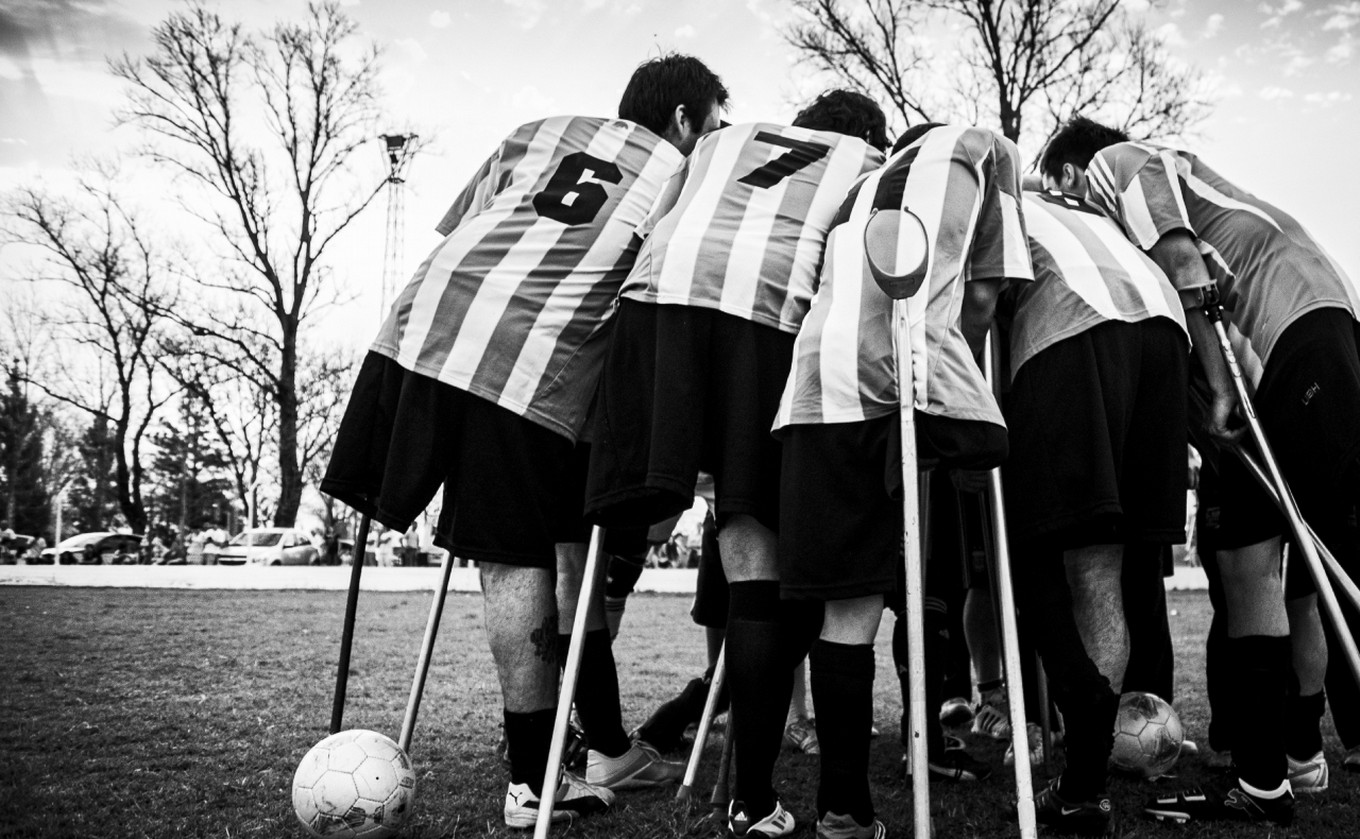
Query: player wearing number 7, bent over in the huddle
588 91 887 836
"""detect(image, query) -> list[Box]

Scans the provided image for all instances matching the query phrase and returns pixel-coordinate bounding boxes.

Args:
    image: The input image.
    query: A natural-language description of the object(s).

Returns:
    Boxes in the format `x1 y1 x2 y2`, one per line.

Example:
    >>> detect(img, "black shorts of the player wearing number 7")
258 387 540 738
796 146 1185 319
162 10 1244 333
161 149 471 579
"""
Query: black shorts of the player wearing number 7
586 299 793 529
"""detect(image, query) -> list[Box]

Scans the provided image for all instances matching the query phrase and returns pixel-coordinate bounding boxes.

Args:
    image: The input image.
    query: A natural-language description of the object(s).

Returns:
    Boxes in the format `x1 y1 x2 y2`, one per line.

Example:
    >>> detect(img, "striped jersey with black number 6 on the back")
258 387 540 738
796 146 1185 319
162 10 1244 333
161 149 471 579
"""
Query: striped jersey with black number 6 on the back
373 117 684 441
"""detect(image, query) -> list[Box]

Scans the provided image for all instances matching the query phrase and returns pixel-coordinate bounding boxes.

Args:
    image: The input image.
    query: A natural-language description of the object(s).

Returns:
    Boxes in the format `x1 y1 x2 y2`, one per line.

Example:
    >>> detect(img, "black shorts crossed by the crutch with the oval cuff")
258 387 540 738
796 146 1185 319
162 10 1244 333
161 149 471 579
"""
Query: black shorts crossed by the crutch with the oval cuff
779 413 1005 600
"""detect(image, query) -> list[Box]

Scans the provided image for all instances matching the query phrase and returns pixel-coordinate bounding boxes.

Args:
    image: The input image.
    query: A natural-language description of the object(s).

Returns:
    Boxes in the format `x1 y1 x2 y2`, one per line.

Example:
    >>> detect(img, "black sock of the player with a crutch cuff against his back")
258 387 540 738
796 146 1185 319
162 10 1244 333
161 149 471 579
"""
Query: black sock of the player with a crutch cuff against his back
810 640 873 824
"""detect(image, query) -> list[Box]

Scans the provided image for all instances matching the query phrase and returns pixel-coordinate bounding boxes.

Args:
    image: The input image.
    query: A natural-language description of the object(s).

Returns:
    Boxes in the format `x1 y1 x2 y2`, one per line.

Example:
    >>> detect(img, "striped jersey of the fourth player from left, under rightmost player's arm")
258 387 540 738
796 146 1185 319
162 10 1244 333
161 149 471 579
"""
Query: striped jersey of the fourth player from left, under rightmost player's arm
1010 192 1190 375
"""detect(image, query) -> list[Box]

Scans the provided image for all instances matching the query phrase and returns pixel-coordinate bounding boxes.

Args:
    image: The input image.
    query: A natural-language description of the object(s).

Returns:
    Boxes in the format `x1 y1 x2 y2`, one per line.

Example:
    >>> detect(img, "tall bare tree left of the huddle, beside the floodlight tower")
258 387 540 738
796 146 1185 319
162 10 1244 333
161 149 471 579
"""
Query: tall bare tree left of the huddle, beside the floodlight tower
112 3 399 525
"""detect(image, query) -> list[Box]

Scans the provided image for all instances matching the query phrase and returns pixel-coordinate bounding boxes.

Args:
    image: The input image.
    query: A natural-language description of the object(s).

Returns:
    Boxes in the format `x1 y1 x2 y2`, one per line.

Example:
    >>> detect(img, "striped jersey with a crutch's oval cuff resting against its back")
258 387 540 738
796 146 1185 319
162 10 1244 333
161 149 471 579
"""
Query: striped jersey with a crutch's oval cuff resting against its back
774 125 1034 430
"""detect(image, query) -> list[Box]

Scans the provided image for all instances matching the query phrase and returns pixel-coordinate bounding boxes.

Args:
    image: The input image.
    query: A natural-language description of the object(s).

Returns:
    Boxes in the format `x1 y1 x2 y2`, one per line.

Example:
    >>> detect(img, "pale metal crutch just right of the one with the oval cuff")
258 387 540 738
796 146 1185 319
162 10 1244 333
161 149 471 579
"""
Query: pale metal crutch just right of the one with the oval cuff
982 328 1038 839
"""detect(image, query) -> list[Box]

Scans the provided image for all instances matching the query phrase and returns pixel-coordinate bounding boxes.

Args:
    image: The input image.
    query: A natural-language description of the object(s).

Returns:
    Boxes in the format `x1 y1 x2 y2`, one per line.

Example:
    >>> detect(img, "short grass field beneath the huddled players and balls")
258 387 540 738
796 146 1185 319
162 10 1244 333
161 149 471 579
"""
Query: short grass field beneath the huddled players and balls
0 587 1360 839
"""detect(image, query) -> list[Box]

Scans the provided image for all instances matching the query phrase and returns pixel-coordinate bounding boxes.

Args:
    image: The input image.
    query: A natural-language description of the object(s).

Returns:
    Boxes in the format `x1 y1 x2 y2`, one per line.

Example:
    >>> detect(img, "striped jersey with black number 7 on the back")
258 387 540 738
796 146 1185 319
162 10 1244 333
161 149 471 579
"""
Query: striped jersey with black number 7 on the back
622 122 883 332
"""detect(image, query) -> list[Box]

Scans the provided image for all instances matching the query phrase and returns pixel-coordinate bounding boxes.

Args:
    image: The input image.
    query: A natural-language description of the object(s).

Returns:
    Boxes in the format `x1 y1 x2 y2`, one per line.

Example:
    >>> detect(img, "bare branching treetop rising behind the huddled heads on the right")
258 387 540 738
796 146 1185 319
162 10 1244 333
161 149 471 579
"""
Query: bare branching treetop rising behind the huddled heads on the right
785 0 1209 143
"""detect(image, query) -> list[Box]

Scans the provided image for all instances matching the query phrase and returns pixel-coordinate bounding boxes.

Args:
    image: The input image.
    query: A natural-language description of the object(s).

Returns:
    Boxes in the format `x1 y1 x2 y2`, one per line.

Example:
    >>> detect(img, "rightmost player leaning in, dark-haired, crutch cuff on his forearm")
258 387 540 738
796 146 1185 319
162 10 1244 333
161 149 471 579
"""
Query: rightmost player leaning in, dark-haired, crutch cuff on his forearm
1040 118 1360 824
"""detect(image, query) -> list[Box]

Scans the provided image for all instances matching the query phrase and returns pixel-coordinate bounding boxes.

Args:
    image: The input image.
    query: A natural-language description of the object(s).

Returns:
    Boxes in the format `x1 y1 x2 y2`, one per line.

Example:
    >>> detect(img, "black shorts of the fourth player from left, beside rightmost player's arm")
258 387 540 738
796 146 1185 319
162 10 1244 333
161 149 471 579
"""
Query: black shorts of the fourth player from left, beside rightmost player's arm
1002 318 1189 548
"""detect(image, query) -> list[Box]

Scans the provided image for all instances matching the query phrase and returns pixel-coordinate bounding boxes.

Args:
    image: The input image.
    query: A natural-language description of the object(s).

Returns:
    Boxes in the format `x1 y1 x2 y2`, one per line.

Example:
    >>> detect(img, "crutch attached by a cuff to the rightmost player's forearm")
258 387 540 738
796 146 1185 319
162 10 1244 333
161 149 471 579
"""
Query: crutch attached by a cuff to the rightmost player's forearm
1204 295 1360 693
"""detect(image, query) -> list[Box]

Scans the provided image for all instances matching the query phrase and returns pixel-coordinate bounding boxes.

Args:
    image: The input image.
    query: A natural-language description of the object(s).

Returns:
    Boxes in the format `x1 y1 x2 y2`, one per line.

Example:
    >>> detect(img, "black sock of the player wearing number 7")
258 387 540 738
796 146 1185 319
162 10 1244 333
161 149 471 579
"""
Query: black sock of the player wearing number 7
725 581 793 820
